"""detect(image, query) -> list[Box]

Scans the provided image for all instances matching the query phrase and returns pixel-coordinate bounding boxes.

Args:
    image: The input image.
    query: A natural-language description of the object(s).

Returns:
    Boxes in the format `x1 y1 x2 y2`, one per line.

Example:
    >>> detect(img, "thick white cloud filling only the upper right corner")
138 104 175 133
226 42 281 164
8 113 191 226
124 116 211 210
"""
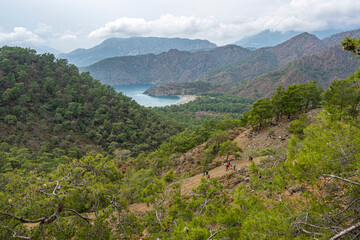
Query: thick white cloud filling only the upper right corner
249 0 360 31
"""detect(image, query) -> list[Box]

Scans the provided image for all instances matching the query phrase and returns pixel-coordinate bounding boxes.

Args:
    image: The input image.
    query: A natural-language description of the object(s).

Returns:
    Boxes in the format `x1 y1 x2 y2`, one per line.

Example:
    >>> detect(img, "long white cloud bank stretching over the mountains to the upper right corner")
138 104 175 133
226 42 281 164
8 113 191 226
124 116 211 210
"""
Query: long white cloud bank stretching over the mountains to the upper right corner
89 0 360 42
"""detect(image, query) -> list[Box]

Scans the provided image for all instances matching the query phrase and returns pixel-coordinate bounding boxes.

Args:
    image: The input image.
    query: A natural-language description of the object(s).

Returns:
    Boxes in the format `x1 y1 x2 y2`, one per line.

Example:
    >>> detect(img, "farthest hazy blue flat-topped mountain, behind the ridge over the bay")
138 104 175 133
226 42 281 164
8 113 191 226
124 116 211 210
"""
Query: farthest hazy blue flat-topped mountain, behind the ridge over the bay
59 37 216 67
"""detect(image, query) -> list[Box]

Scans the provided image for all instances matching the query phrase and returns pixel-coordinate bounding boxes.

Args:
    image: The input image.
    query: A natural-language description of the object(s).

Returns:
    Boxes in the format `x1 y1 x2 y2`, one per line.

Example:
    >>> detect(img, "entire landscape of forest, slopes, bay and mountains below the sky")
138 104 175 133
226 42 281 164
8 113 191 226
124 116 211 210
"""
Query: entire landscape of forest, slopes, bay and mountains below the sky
0 30 360 240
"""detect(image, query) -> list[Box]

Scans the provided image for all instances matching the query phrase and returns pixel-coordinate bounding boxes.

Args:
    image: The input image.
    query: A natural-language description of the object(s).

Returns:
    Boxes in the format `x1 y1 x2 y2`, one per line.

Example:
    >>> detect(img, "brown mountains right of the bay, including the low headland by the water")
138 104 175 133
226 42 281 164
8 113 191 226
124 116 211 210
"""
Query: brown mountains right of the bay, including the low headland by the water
142 30 360 98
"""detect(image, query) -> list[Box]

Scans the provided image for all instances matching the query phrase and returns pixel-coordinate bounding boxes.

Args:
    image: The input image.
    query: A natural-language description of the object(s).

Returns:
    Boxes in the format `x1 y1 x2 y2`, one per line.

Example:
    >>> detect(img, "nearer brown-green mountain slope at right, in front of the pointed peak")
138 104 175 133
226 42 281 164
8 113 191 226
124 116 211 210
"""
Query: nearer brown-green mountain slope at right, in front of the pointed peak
233 46 359 97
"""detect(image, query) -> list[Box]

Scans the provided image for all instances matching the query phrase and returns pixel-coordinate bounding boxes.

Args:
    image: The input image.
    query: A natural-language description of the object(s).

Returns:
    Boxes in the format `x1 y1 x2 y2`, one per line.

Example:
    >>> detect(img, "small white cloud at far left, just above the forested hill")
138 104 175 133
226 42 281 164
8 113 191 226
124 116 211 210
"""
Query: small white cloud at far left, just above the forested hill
0 27 43 44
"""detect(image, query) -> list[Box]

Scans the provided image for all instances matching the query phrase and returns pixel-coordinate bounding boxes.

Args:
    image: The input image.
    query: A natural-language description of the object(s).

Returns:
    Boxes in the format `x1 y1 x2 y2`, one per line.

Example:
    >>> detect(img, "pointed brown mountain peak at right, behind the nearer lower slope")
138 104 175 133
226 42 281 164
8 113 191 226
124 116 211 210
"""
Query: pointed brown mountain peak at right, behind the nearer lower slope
197 33 326 83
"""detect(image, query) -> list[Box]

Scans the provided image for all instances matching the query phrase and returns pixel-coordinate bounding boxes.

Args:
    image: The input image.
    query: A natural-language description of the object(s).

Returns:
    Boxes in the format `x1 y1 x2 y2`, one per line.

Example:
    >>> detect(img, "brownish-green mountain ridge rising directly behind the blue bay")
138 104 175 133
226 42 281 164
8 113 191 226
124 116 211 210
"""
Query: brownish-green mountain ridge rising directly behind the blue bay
82 45 252 85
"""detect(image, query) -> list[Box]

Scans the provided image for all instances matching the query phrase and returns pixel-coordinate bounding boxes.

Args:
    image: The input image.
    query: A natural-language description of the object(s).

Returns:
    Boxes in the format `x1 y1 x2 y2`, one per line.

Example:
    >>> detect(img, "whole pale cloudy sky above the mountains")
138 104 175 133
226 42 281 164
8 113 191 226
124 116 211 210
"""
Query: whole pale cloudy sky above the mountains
0 0 360 52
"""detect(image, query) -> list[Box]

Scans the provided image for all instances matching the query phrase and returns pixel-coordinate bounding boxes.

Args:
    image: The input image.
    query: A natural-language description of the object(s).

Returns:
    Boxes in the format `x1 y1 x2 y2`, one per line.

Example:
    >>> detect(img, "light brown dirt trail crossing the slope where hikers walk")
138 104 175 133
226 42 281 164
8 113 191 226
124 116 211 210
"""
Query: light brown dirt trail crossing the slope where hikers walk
129 157 261 213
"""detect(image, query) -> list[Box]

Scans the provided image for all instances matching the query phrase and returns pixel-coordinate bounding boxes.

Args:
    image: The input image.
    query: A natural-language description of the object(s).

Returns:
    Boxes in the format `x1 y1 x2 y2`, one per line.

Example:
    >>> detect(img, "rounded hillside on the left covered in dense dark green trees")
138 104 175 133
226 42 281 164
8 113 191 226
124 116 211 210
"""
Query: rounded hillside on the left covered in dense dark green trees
0 47 180 172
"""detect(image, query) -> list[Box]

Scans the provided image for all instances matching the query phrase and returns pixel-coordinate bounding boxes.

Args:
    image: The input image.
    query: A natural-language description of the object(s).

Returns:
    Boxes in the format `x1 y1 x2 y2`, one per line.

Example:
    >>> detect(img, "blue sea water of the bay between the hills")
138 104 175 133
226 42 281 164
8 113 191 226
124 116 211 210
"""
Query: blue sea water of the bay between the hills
112 84 180 107
